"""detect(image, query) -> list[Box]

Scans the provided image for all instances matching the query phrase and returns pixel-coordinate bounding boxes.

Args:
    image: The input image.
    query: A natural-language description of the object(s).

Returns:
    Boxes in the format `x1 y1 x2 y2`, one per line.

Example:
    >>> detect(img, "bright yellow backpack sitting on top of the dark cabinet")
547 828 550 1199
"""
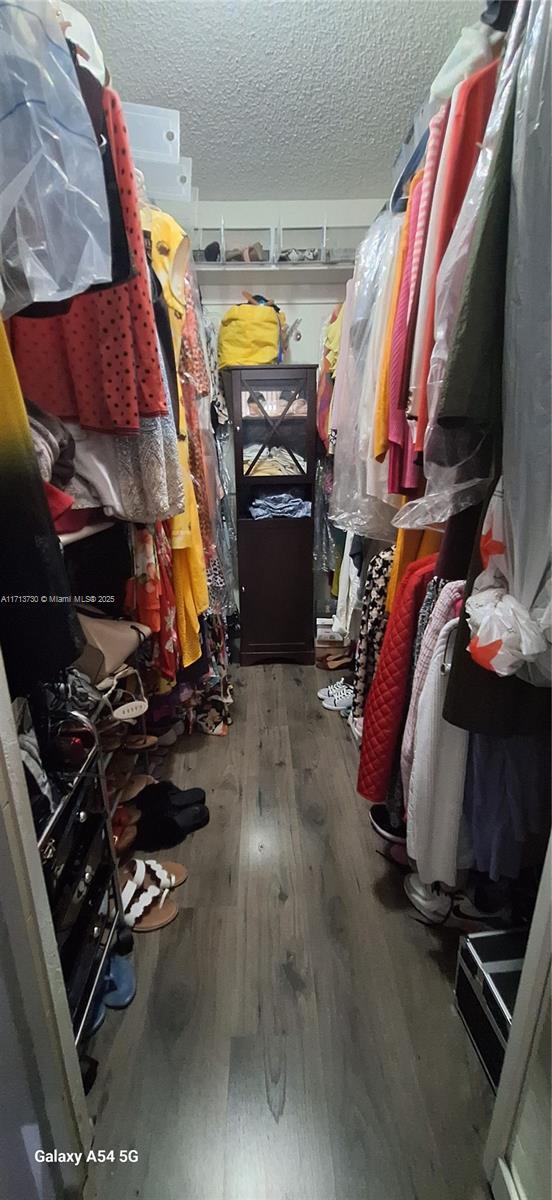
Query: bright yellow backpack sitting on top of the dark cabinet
218 296 286 370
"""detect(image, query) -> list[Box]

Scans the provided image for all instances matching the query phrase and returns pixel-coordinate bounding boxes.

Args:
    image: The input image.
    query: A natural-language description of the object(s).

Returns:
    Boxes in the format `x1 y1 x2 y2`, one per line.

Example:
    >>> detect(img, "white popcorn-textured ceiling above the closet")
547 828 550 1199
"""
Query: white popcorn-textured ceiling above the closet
72 0 484 199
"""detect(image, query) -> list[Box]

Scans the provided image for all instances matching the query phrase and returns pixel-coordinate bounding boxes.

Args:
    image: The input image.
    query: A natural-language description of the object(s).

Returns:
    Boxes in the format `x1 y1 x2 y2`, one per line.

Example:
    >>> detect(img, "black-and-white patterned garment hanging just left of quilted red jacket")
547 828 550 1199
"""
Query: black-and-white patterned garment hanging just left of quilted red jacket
353 546 395 718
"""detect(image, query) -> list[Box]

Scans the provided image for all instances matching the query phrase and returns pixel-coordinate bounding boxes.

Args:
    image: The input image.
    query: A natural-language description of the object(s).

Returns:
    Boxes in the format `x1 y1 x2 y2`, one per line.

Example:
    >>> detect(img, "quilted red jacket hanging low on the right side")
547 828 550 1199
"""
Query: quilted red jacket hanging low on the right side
356 554 437 804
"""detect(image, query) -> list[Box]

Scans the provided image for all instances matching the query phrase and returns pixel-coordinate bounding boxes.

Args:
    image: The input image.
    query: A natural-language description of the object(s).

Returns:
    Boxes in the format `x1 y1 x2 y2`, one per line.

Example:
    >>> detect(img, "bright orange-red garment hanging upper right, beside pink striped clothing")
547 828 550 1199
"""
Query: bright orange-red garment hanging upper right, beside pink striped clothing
415 61 499 451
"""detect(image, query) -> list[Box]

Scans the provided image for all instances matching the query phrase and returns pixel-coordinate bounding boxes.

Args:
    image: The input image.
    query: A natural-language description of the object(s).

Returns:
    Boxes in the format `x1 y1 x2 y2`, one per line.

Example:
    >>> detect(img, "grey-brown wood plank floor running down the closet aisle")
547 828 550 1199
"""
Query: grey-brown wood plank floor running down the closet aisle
89 666 492 1200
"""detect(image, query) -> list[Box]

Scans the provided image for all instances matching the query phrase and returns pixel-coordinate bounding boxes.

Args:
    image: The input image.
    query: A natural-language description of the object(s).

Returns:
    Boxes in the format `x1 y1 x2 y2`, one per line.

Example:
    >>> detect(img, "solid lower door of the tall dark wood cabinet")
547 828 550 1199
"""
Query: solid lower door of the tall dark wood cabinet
238 517 314 664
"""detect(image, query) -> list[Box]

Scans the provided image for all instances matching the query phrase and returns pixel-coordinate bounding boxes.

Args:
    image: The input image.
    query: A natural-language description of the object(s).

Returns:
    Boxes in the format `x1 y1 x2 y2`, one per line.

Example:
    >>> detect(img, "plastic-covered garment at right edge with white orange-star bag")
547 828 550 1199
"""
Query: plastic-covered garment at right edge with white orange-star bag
468 2 552 685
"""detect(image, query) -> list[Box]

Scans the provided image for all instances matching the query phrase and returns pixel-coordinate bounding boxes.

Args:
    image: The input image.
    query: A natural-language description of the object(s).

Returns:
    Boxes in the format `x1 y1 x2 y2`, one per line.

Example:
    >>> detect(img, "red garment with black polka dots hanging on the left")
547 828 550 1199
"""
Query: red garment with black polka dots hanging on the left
11 88 167 433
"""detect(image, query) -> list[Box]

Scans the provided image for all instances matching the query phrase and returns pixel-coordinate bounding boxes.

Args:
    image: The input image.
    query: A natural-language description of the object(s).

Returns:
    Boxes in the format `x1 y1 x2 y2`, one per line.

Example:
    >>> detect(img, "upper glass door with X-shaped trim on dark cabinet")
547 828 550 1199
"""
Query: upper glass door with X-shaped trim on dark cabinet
241 374 307 479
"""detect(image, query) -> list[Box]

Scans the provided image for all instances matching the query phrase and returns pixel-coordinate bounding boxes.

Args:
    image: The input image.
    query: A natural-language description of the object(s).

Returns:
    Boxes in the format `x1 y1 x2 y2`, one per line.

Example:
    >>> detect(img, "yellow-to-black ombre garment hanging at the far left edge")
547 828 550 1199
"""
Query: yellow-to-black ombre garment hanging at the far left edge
0 322 84 697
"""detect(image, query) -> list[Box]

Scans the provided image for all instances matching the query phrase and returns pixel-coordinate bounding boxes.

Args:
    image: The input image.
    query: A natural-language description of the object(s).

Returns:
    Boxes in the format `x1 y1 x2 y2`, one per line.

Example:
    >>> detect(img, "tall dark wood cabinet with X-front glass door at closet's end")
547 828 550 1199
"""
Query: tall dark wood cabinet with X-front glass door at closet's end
222 366 317 666
